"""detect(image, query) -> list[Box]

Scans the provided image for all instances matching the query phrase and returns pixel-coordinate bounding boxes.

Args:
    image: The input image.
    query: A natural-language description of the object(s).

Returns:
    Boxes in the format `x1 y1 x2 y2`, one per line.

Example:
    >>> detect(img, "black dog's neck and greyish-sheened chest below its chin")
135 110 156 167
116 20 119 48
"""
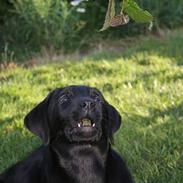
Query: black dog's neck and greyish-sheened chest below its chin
52 140 109 183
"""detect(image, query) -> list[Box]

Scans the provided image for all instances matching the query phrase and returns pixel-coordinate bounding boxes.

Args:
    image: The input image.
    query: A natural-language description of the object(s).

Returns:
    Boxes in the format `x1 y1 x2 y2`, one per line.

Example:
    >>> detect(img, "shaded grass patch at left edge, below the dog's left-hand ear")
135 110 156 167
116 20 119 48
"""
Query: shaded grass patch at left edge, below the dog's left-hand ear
0 129 40 173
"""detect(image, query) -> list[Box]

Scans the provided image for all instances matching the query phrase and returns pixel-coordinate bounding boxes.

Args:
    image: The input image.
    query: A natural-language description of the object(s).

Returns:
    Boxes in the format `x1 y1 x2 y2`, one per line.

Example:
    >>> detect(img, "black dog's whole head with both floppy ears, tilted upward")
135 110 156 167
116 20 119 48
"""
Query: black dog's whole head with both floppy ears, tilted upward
25 86 121 144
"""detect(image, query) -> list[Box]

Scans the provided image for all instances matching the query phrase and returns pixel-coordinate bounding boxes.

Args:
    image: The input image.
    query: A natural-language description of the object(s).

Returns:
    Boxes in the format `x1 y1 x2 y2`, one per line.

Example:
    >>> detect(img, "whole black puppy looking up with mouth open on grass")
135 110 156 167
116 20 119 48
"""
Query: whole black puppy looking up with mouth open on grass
0 86 133 183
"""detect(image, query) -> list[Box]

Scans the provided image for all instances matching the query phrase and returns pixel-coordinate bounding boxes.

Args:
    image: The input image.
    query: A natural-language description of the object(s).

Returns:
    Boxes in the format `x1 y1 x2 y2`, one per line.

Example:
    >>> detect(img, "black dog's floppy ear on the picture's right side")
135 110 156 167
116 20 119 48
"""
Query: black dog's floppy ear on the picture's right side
106 103 121 136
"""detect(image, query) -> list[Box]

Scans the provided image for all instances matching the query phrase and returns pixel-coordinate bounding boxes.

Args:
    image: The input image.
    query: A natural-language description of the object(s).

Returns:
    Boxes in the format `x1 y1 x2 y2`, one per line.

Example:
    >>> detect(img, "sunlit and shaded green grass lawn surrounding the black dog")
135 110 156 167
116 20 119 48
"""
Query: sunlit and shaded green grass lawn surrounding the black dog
0 30 183 183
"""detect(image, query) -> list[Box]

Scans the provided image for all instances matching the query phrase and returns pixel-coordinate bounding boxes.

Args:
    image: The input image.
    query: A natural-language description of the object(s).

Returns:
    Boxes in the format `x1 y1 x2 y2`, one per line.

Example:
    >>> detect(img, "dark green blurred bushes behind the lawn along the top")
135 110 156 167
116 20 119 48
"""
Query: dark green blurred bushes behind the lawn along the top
0 0 183 61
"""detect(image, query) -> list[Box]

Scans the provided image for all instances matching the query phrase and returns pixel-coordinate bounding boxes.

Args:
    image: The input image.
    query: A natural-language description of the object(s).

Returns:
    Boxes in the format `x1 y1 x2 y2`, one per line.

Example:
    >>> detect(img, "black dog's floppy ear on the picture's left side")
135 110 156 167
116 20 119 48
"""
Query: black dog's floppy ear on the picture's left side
24 94 51 144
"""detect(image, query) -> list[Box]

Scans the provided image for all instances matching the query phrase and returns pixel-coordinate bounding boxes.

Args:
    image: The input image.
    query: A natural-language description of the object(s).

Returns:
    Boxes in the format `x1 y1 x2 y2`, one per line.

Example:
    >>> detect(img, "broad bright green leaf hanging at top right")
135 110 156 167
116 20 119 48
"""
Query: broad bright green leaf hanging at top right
123 0 153 23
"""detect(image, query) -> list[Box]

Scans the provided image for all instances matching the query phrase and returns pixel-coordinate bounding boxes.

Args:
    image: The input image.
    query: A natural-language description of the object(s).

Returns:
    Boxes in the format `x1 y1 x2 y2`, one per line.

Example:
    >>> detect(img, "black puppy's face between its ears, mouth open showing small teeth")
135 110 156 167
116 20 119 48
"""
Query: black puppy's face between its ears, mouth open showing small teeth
58 86 104 141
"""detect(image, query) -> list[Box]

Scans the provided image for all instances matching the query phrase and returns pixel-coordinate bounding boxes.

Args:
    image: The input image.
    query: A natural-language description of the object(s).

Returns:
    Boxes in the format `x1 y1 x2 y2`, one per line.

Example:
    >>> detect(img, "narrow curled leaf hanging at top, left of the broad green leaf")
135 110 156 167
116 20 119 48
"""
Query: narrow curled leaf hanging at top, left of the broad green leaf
100 0 115 31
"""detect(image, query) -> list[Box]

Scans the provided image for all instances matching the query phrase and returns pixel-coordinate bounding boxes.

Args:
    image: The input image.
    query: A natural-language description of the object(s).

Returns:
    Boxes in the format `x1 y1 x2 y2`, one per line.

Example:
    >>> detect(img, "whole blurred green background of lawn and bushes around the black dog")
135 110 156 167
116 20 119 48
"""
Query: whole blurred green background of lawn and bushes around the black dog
0 0 183 183
